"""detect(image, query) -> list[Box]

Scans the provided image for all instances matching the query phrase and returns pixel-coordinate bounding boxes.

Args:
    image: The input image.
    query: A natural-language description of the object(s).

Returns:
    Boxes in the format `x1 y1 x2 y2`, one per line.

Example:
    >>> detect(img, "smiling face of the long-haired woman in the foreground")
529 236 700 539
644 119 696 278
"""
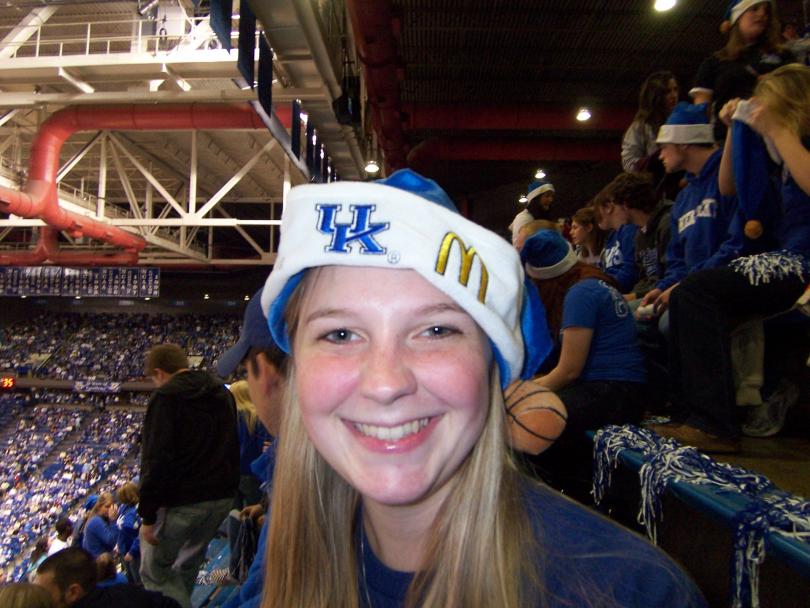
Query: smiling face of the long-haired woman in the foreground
293 266 491 506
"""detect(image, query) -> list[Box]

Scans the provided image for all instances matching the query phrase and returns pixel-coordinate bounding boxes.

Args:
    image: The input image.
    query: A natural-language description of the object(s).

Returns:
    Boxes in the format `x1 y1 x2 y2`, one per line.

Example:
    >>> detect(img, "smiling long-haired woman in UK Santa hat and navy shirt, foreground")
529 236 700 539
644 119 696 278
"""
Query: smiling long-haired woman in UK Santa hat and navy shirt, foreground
254 170 705 608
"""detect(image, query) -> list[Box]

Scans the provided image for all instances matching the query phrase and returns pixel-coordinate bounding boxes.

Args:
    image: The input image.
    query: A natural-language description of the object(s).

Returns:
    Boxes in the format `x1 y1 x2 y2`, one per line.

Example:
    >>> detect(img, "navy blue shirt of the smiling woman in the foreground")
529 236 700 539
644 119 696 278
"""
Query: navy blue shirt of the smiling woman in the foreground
358 481 706 608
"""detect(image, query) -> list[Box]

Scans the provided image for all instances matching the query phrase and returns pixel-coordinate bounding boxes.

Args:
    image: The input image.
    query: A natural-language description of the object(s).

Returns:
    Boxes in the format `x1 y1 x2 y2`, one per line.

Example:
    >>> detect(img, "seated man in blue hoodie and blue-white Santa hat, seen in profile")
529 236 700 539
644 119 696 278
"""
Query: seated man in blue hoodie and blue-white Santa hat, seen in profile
641 102 744 318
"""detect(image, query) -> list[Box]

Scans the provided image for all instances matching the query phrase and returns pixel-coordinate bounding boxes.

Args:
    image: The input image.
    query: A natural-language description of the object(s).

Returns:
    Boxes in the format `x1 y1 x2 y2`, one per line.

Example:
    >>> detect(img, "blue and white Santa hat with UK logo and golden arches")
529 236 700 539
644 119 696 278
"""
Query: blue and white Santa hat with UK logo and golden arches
261 169 551 387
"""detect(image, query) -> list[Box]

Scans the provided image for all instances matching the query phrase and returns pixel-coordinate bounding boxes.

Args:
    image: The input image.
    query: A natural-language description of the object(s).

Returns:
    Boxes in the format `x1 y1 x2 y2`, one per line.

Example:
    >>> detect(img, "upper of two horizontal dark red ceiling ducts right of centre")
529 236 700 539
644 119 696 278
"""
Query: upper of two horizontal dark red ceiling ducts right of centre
404 106 635 132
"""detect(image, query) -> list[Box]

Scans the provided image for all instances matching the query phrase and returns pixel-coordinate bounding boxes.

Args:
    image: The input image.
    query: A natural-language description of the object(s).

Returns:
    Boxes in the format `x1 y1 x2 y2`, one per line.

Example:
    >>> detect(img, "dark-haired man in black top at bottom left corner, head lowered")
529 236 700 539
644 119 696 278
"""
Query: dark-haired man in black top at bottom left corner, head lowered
34 547 179 608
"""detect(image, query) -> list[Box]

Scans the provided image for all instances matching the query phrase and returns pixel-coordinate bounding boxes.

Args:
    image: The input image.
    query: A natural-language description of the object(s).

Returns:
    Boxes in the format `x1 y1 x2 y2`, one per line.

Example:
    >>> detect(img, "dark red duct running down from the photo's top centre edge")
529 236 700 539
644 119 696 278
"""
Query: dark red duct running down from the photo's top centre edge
346 0 407 169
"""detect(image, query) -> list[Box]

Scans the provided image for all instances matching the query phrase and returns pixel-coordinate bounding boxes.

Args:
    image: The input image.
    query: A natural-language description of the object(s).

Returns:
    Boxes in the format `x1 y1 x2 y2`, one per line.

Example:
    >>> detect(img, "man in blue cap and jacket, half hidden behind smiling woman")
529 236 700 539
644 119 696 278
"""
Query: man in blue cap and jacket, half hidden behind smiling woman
216 290 288 608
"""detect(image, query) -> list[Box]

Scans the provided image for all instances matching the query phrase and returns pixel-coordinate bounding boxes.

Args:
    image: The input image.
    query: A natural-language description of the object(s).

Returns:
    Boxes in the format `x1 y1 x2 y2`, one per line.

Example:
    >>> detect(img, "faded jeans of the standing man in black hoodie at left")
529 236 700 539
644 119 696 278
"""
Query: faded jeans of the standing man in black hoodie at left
141 498 233 608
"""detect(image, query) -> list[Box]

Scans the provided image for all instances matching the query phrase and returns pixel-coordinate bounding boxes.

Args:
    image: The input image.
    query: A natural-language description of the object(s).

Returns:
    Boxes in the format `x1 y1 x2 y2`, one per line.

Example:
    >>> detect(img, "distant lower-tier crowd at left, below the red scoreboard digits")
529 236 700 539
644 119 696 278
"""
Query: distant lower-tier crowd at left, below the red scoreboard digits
0 404 143 580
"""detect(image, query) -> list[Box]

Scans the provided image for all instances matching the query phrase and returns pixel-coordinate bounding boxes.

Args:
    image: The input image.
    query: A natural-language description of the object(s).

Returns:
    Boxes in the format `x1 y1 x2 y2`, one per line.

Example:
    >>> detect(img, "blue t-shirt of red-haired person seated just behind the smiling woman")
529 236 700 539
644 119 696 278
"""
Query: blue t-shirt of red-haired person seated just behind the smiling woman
562 279 646 382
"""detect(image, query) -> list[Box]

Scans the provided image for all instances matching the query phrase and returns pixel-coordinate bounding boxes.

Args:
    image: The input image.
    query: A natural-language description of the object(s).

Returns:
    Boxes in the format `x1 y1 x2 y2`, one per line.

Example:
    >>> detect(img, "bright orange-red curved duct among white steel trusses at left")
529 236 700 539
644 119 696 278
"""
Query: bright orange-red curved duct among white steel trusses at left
0 103 291 264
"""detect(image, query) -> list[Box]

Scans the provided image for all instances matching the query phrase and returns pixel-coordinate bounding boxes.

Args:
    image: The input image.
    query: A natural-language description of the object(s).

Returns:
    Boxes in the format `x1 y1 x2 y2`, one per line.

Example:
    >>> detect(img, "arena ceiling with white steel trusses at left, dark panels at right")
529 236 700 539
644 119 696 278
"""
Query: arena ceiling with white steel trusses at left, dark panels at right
0 0 802 266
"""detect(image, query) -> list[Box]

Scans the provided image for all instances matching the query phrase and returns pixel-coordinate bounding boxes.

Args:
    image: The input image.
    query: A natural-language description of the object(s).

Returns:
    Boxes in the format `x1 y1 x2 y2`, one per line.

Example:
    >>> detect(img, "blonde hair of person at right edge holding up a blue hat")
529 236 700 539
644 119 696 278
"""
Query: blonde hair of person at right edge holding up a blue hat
754 63 810 137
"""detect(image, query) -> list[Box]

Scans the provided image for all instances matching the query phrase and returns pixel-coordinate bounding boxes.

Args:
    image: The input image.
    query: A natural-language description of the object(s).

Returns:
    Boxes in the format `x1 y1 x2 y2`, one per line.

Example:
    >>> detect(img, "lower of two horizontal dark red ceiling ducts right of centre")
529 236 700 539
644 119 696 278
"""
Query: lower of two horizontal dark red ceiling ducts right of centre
408 138 619 172
